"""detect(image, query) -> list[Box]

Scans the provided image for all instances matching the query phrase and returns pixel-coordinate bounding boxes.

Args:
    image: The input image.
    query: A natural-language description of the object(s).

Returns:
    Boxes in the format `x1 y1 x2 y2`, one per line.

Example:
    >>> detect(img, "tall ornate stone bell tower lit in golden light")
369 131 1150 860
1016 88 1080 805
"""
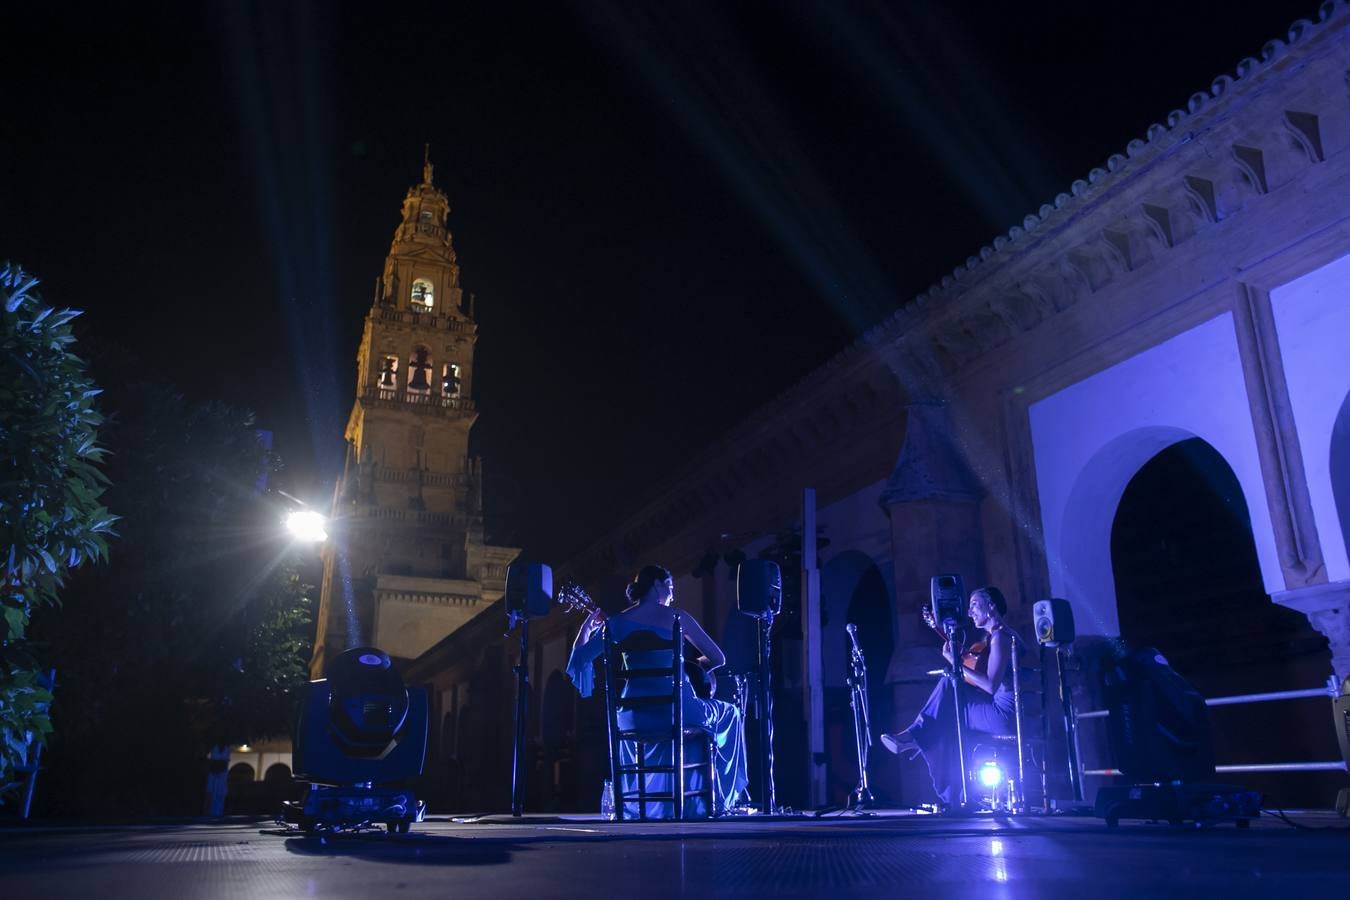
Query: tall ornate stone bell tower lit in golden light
311 154 518 677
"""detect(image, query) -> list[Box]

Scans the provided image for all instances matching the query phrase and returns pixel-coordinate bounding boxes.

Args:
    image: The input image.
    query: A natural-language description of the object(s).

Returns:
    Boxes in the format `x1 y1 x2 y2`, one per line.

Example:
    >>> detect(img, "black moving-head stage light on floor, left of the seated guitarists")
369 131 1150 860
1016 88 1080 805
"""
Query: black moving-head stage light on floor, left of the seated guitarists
282 646 427 834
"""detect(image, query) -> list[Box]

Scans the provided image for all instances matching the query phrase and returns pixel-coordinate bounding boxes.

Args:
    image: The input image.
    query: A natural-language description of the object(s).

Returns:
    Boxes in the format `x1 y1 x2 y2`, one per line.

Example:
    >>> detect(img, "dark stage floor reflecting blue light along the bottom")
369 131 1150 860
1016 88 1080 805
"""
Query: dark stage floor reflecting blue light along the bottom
0 812 1350 900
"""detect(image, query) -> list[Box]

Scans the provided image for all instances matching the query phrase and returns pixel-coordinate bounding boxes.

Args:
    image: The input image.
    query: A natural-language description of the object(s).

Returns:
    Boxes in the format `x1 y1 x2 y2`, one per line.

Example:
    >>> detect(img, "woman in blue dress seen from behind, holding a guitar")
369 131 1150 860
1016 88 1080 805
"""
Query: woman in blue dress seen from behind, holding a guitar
567 565 749 815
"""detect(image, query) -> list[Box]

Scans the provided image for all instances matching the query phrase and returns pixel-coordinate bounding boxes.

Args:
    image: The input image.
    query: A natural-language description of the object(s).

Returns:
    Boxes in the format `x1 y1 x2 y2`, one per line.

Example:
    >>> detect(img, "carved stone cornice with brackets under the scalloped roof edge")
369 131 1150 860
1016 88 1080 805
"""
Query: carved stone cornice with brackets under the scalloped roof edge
864 0 1350 379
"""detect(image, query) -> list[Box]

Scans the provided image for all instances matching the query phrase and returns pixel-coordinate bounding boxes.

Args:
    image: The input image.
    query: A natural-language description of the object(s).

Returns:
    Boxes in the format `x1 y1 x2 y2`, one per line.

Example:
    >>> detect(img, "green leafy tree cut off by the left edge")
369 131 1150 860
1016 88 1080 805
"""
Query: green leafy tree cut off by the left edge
0 263 117 785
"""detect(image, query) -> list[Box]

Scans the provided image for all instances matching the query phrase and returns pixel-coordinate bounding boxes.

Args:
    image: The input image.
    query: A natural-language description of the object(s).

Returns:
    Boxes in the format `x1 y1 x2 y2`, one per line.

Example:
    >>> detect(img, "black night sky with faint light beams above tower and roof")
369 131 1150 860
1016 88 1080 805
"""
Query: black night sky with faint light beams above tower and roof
0 0 1316 557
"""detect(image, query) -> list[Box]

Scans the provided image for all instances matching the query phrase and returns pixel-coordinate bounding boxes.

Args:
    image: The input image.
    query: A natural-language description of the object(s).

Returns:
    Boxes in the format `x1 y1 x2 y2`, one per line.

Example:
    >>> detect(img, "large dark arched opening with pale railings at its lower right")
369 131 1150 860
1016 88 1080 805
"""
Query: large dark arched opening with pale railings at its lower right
1111 439 1335 806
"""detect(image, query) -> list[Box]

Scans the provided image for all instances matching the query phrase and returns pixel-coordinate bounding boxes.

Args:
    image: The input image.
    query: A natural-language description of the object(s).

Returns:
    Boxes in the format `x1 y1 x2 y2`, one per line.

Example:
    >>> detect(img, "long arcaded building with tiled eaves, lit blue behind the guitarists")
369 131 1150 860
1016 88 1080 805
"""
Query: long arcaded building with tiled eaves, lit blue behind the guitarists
413 4 1350 808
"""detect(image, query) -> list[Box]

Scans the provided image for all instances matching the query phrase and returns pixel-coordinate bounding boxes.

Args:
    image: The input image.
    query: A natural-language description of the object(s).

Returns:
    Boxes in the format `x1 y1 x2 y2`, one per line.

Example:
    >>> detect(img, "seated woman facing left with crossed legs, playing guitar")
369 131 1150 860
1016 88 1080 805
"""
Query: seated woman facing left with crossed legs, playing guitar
882 587 1017 807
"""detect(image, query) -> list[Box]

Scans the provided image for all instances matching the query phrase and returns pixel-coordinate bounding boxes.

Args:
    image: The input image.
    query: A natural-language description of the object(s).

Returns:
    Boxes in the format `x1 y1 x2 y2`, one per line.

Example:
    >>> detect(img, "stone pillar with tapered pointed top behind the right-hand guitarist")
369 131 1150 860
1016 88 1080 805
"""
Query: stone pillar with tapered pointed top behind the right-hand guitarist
869 402 984 804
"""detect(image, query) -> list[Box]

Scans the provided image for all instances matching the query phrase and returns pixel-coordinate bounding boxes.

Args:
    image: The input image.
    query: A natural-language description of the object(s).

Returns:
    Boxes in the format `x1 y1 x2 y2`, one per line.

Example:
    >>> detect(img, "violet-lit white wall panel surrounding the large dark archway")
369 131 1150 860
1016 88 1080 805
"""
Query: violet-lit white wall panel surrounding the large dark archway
1029 313 1284 634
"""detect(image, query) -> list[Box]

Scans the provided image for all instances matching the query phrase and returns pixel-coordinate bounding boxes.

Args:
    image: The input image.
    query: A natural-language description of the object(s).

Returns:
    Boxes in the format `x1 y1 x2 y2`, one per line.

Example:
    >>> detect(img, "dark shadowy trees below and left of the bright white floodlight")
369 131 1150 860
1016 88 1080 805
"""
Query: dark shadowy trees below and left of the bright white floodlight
34 350 312 815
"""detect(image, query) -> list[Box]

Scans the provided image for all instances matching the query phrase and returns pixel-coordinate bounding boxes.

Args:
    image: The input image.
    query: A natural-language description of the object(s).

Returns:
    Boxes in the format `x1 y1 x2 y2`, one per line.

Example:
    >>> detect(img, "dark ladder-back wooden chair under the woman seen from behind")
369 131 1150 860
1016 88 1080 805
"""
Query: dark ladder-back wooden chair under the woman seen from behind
605 615 714 822
